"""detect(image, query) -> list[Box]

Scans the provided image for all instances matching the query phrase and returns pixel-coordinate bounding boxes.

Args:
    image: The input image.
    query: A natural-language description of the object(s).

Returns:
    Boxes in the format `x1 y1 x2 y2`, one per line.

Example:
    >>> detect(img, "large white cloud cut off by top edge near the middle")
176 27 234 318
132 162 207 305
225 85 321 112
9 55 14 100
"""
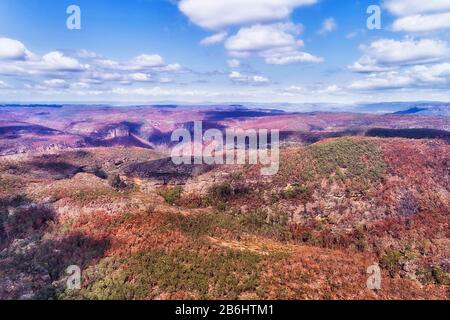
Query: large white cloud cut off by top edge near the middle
178 0 317 29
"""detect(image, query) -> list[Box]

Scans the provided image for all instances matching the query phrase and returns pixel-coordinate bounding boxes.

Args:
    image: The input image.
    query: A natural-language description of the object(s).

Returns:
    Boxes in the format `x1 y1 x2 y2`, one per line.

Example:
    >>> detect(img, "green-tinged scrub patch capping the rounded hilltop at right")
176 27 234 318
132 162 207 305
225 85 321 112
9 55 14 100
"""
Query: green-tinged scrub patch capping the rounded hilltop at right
275 138 387 192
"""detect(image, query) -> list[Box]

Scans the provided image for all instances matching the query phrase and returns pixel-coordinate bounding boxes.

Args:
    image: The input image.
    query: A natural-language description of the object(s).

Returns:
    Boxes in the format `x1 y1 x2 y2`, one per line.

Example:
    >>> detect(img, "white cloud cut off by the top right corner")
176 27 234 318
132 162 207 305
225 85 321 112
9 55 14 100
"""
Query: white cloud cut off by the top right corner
384 0 450 32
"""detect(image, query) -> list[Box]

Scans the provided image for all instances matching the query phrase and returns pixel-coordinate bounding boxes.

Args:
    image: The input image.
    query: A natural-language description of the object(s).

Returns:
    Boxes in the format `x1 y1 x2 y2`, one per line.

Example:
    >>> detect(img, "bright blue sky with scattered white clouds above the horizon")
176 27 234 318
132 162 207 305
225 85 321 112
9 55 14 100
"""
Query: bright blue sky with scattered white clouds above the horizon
0 0 450 103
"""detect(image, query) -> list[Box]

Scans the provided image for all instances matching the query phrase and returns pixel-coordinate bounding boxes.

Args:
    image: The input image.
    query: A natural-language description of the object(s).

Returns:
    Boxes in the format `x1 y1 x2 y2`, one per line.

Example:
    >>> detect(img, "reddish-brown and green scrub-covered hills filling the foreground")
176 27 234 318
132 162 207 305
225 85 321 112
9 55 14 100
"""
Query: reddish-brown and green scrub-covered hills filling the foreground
0 137 450 299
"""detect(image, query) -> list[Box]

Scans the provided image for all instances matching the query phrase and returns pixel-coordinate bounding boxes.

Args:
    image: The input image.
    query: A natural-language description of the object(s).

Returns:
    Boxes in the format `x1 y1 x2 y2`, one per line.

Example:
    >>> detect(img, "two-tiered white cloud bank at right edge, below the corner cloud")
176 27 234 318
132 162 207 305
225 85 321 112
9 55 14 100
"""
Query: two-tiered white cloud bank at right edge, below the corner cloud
348 35 450 92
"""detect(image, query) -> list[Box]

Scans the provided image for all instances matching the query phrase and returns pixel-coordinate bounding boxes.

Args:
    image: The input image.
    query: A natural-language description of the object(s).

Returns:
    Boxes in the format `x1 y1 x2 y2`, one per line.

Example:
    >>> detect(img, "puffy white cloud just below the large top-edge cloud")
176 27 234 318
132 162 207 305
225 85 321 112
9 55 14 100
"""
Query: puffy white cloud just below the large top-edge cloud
225 23 322 64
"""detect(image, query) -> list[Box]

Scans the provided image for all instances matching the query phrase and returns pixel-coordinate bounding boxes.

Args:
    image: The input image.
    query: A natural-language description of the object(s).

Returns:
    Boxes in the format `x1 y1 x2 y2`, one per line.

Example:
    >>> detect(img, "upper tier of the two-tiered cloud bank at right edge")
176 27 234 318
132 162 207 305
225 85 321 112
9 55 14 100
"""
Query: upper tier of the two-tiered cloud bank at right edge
350 39 450 72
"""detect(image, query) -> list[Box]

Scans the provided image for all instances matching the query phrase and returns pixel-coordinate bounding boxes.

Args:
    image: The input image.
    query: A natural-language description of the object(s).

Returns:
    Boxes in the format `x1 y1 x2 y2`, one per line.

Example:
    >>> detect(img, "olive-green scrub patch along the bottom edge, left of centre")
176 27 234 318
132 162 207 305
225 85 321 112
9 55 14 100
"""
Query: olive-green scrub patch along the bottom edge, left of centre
61 248 261 300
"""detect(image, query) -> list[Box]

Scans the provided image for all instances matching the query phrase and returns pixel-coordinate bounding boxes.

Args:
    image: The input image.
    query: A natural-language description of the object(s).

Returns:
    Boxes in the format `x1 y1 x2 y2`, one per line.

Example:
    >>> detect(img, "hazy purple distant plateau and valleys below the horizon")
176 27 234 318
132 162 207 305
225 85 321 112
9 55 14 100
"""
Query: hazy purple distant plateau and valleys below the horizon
0 104 449 154
